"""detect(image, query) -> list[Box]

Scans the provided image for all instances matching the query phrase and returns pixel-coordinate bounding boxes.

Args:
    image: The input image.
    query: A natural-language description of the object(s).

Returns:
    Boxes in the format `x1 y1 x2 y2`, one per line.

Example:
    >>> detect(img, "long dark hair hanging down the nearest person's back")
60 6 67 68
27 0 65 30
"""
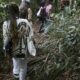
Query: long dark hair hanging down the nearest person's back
7 3 19 47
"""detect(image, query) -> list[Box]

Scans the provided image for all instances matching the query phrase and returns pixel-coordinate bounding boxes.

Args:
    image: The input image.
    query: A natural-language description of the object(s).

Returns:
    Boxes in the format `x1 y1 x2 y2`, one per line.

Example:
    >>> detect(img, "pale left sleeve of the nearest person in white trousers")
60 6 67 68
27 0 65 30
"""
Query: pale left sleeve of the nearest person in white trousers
3 22 8 50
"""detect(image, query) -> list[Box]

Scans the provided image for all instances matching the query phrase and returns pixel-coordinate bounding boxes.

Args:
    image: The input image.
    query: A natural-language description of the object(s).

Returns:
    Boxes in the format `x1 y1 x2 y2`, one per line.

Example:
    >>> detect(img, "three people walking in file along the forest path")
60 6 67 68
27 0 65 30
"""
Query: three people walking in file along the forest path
3 0 52 80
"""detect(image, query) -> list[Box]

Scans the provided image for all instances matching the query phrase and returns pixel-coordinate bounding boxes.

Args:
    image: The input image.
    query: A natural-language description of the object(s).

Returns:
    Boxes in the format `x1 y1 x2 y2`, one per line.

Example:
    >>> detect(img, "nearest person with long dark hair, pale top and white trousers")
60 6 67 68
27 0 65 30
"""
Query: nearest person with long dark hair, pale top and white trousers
3 3 36 80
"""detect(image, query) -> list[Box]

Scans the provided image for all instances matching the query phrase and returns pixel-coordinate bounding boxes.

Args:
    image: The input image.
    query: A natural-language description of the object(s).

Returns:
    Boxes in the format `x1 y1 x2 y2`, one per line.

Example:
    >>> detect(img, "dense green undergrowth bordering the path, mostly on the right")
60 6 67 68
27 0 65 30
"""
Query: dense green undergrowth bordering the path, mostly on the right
0 0 80 80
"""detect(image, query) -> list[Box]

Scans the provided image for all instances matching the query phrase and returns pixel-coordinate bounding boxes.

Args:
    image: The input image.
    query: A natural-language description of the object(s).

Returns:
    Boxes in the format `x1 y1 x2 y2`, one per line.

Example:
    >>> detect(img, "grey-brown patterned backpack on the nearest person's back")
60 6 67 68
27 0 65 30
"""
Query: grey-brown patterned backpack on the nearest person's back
13 22 30 58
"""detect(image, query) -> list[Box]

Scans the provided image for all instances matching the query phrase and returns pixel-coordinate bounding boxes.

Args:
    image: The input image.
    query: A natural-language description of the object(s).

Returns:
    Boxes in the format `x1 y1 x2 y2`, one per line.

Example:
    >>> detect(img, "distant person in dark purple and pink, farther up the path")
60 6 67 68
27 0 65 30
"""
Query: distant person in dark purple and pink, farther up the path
37 0 53 33
